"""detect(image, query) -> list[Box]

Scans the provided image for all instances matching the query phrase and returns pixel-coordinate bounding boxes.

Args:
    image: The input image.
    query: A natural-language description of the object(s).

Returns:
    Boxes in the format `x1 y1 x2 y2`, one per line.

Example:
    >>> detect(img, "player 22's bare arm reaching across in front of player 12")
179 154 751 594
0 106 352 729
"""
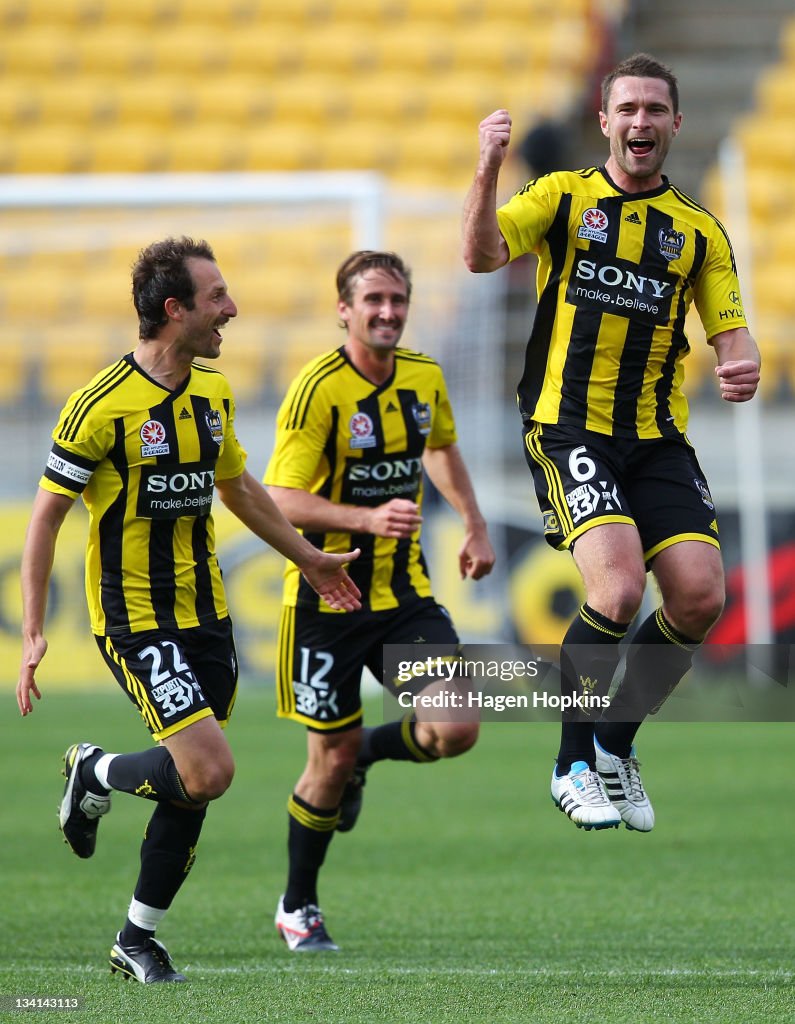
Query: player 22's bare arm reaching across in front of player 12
215 470 362 611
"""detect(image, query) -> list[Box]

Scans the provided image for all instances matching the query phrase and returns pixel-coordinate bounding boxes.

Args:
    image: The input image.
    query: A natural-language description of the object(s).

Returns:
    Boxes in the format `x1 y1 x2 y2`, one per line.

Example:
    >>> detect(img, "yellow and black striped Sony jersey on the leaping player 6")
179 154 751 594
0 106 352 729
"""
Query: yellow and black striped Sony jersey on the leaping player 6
497 167 746 438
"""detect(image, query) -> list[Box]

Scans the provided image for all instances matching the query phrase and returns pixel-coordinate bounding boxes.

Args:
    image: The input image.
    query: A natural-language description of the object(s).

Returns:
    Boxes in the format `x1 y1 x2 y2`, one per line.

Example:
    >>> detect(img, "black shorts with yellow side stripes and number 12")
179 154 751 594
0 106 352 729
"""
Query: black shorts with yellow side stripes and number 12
277 598 460 732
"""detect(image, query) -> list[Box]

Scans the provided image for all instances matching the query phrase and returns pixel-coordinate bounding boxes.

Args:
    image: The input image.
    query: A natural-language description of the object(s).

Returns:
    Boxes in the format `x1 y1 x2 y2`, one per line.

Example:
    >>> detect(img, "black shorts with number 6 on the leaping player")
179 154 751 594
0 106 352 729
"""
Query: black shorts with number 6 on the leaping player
525 423 720 565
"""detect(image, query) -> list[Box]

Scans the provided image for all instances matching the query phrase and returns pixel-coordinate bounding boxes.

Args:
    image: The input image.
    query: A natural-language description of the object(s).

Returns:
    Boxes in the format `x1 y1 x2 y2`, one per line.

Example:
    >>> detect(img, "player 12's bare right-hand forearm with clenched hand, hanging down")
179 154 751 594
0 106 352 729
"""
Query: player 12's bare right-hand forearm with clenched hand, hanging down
422 444 495 580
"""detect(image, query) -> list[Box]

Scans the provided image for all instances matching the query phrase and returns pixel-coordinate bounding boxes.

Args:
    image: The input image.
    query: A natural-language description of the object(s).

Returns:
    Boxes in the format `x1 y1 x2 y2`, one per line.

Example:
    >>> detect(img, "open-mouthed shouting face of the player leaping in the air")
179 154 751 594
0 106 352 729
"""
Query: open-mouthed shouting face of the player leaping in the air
599 76 682 193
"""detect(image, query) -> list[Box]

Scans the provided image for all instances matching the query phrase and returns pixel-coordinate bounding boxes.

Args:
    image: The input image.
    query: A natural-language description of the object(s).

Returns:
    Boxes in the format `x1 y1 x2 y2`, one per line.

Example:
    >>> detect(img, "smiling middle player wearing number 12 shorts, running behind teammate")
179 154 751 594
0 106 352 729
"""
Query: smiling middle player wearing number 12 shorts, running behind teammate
265 251 494 952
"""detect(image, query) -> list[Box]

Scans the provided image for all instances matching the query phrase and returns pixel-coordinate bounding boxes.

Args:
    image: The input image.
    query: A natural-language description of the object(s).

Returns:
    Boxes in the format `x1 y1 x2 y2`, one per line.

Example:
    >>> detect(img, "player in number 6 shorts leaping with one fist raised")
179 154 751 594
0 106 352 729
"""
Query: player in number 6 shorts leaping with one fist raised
464 53 760 831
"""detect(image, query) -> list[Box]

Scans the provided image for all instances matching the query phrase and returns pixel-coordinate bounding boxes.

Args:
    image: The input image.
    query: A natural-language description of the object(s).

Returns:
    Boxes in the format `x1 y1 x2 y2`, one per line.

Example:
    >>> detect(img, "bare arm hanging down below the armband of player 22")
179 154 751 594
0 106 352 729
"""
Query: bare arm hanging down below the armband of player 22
16 488 75 716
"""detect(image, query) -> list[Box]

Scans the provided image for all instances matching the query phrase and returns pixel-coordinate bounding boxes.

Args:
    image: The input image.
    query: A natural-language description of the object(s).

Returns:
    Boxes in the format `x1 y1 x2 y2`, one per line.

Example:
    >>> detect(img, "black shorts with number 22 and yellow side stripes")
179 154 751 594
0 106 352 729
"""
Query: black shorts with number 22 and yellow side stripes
96 618 238 739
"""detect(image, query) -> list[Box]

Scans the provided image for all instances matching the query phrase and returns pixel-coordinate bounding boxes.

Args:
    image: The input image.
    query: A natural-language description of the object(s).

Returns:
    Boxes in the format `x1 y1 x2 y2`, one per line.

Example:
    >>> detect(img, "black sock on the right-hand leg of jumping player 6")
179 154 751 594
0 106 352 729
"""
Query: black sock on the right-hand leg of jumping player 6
596 608 700 758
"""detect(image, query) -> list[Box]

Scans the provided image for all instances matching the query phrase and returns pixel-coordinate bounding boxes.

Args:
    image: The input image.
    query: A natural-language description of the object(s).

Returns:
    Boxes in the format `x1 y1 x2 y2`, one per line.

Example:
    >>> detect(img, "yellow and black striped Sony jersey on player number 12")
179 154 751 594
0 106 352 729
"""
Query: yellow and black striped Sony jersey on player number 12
264 347 456 611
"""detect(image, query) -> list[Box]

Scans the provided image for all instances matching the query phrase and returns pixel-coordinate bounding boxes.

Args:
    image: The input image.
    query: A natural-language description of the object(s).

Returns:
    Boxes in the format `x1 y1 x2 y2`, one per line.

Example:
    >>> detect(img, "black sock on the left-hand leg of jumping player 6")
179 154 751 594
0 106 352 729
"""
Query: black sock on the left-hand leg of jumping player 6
557 604 629 776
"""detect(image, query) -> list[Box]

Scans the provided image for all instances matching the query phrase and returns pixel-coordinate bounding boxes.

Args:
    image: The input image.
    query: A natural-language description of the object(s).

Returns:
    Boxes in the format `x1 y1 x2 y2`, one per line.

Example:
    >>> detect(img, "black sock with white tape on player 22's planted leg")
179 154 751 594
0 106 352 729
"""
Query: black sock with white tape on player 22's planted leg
121 803 207 945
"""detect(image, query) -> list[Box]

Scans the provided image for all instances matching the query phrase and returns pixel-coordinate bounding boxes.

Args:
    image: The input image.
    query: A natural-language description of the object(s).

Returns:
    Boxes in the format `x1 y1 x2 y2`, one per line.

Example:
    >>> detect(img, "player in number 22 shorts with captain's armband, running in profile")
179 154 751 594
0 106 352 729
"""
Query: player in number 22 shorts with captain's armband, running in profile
16 239 360 983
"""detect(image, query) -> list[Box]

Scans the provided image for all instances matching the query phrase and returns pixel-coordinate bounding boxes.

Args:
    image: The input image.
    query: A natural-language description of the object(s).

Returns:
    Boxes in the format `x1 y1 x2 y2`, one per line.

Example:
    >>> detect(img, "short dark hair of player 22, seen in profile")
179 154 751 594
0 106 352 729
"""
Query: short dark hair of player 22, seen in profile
132 236 215 338
